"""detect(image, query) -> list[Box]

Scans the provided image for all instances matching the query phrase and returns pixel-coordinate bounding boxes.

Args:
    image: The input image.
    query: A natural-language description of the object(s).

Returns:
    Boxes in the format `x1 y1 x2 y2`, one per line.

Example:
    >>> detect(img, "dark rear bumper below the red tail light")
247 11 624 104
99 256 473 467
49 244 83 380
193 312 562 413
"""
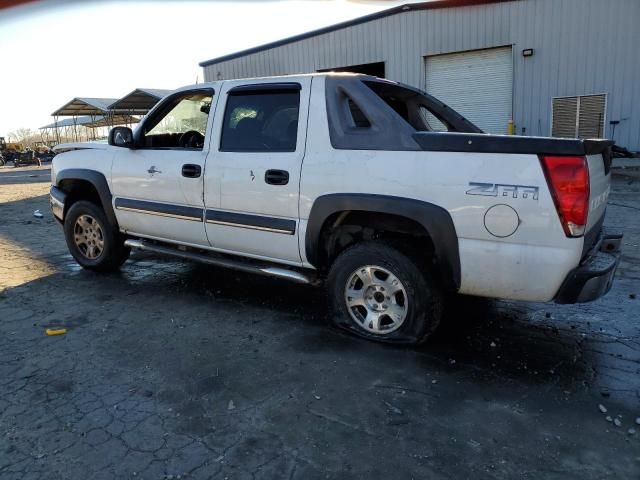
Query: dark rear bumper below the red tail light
554 229 622 303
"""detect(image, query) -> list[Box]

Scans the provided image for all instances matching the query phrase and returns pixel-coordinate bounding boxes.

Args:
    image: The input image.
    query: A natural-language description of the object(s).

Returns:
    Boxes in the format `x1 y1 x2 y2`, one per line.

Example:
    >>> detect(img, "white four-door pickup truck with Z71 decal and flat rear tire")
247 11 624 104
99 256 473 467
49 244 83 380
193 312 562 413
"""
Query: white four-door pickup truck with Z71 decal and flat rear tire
51 74 622 344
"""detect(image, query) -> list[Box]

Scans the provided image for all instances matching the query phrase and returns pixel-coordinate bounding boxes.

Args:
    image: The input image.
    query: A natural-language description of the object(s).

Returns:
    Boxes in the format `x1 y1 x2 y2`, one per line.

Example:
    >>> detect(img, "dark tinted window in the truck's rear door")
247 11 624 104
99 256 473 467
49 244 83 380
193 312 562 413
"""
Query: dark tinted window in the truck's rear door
220 90 300 152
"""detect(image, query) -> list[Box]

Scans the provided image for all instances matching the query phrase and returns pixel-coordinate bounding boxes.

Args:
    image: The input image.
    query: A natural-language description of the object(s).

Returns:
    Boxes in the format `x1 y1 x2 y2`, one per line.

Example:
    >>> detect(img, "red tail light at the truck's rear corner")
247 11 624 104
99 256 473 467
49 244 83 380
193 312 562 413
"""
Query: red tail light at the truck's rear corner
542 156 589 237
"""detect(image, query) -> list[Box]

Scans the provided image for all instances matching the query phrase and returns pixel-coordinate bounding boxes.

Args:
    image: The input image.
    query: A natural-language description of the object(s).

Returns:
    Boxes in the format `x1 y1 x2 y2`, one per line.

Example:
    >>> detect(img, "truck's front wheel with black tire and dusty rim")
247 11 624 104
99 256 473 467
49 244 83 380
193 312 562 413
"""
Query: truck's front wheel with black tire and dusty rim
64 200 130 272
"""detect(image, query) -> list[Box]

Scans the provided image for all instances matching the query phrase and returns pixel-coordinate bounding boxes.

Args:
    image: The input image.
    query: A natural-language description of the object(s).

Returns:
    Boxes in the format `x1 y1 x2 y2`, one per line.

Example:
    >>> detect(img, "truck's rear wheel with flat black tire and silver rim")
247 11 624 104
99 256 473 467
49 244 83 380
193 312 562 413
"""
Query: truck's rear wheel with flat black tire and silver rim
328 242 443 345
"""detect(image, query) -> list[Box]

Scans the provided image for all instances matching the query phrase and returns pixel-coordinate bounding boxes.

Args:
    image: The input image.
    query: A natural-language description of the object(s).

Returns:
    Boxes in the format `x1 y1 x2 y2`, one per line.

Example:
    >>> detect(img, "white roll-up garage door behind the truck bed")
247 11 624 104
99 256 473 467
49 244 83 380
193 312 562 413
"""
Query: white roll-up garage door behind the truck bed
425 47 513 134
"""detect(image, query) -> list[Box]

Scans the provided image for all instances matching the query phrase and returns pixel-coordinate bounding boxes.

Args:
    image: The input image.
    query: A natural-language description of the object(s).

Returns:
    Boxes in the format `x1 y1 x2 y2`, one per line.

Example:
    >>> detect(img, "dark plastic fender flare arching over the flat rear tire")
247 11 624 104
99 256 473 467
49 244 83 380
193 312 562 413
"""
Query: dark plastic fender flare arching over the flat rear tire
305 193 461 290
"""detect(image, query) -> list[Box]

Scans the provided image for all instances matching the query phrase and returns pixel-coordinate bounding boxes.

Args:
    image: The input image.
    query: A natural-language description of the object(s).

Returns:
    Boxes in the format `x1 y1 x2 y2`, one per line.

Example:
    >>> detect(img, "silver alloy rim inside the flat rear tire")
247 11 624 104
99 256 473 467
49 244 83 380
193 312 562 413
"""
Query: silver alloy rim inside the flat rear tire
344 265 409 335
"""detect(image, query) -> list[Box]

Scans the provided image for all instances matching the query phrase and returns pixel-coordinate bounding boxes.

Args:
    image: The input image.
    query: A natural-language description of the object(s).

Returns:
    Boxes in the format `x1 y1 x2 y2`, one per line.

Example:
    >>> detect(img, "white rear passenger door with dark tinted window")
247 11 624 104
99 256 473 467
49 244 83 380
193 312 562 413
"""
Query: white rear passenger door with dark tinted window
204 78 311 264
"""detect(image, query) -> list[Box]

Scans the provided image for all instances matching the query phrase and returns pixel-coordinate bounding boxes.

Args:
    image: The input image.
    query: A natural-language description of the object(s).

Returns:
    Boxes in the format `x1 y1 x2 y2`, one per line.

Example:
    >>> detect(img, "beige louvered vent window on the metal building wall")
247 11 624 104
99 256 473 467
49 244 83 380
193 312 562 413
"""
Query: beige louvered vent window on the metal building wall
551 95 605 138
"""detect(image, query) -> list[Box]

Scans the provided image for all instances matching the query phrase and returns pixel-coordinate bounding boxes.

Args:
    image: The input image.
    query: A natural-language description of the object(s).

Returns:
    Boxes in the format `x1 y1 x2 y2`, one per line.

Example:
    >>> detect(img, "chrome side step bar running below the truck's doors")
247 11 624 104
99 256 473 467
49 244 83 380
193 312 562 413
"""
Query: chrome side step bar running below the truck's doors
124 239 318 285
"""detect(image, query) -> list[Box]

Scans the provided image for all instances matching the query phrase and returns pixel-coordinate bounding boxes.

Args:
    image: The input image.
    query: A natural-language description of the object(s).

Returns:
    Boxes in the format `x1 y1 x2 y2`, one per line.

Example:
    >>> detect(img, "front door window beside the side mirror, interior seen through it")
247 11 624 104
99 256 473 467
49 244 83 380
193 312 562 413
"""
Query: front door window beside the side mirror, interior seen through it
143 92 212 149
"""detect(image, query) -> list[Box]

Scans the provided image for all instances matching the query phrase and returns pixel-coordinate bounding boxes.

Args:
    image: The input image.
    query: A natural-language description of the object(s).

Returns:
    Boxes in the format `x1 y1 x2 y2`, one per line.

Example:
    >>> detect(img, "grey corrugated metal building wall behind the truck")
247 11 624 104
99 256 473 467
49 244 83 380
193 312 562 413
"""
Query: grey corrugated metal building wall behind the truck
204 0 640 150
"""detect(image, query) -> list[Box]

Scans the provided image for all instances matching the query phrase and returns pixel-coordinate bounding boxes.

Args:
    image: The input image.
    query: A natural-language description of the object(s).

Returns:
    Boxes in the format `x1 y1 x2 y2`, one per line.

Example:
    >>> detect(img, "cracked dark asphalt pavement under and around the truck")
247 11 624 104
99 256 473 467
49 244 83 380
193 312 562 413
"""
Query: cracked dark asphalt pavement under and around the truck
0 163 640 480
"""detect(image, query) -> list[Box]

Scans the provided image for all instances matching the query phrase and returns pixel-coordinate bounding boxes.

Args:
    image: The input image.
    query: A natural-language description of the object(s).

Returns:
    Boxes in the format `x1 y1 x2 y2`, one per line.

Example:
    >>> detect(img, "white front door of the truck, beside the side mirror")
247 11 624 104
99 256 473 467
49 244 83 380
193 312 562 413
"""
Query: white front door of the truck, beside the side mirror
111 89 215 246
